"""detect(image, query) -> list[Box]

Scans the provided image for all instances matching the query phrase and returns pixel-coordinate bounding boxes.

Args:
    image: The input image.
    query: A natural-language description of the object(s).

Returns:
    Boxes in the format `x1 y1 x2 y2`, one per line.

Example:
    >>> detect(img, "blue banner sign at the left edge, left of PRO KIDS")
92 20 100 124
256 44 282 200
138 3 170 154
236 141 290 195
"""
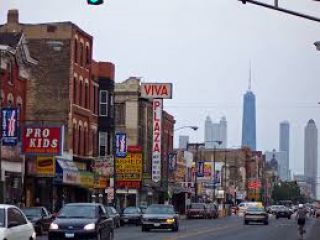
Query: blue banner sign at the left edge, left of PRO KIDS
1 108 18 146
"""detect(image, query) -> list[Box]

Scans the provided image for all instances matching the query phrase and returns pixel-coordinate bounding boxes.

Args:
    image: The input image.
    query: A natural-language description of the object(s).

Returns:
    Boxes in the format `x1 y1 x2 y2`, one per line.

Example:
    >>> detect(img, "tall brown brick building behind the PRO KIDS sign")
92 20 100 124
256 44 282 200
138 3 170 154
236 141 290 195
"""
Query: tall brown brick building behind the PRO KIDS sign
0 10 114 209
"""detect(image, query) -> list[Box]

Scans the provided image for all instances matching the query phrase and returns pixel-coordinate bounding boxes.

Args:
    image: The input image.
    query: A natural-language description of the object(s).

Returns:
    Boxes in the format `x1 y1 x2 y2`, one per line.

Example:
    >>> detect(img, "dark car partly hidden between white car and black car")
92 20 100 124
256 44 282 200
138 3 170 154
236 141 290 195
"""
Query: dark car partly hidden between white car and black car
21 207 54 235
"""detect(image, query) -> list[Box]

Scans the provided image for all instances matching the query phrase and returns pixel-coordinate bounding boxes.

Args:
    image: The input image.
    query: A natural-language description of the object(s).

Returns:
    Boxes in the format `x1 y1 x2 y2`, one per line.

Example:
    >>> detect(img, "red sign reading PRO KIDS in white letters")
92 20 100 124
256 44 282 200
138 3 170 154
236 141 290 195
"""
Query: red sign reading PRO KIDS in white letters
22 126 64 155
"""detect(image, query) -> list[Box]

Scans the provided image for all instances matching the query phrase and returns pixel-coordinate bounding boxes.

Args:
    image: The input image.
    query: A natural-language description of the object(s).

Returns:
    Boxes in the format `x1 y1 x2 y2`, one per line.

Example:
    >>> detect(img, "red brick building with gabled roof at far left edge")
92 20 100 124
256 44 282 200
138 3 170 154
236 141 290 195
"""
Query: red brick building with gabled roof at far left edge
0 33 37 203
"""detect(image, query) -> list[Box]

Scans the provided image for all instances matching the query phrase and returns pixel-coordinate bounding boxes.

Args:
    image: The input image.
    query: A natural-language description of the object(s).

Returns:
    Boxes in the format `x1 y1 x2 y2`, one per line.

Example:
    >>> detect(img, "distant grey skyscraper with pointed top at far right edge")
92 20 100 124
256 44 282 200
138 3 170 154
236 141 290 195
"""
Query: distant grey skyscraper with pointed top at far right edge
304 119 318 197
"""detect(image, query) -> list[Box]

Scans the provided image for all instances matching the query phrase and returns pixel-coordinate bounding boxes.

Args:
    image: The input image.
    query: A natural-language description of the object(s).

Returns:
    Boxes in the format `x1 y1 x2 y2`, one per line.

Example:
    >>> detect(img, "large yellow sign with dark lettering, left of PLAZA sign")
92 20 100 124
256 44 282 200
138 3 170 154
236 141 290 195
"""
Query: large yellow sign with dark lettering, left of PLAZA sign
116 152 142 181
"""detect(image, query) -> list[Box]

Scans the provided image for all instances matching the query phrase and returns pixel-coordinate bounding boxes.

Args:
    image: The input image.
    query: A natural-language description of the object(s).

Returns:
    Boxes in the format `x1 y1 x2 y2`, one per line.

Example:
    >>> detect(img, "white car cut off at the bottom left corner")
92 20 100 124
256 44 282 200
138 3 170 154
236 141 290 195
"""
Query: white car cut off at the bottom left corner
0 204 36 240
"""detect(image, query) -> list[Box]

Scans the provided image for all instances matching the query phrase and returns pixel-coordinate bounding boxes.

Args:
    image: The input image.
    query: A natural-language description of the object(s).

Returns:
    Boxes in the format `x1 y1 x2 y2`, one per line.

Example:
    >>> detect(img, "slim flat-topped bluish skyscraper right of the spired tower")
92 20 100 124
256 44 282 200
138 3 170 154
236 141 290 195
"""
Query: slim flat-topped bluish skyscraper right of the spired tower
279 121 290 181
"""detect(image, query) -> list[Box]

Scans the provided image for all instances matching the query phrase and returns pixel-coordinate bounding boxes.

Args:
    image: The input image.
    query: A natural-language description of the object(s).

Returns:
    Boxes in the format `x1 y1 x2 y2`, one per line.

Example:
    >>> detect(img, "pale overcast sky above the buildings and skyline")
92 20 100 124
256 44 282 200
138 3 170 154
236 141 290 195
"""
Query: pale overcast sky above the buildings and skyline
0 0 320 173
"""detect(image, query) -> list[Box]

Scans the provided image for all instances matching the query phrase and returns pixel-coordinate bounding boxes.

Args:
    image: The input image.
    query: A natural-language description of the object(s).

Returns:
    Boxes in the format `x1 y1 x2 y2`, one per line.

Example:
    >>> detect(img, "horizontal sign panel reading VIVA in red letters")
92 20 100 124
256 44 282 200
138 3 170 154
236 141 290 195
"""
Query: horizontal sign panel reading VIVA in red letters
141 83 172 99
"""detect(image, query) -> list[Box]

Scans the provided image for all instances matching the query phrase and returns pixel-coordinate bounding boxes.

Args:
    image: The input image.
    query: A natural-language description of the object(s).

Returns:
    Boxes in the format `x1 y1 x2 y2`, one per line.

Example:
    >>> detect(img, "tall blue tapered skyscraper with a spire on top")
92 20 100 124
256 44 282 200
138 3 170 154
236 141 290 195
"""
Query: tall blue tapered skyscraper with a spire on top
241 71 256 150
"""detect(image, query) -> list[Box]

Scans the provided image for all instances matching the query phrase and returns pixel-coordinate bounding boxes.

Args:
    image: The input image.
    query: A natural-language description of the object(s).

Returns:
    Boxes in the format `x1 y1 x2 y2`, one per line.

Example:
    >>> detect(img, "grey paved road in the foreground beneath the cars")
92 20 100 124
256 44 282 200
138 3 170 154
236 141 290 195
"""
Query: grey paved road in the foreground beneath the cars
37 216 320 240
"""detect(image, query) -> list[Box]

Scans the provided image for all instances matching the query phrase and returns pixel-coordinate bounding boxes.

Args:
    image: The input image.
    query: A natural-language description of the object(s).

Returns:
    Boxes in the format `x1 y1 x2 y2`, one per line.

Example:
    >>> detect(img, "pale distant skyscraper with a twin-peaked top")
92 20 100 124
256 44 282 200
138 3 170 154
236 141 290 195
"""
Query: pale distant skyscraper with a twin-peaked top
204 116 227 148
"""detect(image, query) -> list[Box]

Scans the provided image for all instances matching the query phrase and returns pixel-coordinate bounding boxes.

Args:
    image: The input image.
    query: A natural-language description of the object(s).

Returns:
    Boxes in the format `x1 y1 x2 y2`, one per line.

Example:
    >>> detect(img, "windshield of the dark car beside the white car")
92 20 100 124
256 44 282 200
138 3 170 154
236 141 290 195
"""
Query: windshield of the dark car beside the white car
58 205 96 218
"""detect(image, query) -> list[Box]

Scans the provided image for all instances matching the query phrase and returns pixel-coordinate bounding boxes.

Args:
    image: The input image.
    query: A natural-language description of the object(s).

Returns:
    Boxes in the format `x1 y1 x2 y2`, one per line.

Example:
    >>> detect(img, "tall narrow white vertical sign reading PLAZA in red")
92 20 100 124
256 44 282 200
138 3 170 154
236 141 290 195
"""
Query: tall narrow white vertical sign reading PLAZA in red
152 99 163 183
